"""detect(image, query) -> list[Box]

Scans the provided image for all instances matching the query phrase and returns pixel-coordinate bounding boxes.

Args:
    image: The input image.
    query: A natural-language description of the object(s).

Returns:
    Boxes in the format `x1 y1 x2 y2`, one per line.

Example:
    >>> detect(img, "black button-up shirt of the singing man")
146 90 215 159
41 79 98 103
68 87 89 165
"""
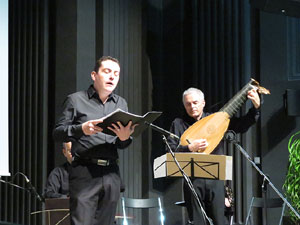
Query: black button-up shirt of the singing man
53 85 131 159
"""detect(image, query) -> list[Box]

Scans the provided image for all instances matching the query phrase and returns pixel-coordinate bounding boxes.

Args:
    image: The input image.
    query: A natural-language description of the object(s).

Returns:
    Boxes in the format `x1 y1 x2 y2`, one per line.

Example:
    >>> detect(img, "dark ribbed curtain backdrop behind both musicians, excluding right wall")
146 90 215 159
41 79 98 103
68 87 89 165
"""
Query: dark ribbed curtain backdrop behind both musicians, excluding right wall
0 0 270 225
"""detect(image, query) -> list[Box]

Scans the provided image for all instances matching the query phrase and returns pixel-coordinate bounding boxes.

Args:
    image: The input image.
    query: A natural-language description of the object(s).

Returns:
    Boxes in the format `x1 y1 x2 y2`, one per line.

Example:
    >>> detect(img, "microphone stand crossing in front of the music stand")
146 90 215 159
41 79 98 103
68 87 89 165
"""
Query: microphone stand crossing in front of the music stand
145 121 213 225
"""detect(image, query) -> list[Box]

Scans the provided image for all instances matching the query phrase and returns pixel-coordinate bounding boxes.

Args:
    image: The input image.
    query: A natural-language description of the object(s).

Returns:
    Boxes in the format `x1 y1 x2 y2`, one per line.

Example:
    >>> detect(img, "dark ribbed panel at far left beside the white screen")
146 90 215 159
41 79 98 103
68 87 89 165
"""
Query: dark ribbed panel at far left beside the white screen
0 0 47 225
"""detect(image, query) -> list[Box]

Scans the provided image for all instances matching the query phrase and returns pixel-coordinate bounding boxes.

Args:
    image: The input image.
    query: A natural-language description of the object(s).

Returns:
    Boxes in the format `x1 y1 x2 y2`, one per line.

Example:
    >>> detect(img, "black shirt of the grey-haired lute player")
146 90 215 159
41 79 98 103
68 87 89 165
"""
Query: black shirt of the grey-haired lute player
168 107 260 155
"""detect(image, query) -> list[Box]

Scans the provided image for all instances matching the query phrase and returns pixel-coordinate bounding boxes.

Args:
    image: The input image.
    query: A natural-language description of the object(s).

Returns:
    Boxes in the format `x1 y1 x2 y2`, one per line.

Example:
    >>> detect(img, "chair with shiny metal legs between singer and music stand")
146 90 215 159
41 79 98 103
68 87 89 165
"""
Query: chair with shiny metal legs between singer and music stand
121 197 165 225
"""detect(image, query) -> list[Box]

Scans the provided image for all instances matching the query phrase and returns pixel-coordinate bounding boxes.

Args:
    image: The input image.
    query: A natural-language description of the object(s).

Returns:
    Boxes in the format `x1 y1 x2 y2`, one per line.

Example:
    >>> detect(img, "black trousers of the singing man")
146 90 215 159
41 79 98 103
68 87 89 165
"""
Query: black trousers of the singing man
69 163 121 225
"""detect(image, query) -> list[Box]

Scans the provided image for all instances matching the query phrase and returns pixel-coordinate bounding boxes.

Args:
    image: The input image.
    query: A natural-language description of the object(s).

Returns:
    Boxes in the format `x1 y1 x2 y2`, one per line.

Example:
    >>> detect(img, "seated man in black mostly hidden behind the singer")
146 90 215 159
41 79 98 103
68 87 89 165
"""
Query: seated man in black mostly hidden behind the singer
44 142 72 198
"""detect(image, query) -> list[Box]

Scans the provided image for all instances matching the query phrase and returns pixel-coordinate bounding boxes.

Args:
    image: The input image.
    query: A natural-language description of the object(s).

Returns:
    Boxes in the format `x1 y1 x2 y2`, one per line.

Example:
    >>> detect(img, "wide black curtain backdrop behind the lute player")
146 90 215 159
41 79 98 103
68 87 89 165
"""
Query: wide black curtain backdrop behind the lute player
147 0 259 223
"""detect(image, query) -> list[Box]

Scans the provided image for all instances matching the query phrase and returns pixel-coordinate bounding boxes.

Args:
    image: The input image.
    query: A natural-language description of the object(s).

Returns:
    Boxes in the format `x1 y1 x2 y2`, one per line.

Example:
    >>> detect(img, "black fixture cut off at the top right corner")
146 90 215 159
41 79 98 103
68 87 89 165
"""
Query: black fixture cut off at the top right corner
249 0 300 17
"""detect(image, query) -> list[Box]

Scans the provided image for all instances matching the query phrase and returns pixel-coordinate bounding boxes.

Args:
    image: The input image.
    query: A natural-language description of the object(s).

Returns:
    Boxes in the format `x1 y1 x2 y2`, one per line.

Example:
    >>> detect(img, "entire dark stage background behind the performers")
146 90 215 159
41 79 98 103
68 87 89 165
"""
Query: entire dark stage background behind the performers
0 0 300 225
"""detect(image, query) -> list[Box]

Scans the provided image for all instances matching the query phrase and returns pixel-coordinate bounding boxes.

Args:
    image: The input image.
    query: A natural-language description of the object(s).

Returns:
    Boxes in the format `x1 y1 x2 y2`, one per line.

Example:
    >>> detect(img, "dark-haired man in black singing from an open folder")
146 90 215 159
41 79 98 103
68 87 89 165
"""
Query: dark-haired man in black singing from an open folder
53 56 134 225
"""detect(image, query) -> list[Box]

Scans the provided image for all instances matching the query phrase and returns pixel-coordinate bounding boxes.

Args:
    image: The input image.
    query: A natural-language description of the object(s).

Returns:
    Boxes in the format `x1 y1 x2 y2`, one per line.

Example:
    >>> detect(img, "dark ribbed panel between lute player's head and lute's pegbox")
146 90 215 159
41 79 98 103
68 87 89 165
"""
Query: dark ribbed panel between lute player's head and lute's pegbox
193 0 250 222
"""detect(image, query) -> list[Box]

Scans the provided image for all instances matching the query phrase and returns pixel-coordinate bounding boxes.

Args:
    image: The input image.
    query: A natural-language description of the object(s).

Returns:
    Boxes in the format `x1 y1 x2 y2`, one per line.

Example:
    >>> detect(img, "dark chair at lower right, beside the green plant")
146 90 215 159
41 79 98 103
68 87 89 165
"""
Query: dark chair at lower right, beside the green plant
245 197 285 225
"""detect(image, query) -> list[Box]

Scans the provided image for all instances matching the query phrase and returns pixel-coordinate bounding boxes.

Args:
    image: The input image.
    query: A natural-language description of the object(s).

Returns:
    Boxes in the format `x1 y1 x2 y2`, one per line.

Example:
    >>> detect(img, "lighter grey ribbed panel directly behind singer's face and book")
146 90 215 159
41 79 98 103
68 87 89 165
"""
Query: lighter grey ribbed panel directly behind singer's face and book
100 0 145 224
